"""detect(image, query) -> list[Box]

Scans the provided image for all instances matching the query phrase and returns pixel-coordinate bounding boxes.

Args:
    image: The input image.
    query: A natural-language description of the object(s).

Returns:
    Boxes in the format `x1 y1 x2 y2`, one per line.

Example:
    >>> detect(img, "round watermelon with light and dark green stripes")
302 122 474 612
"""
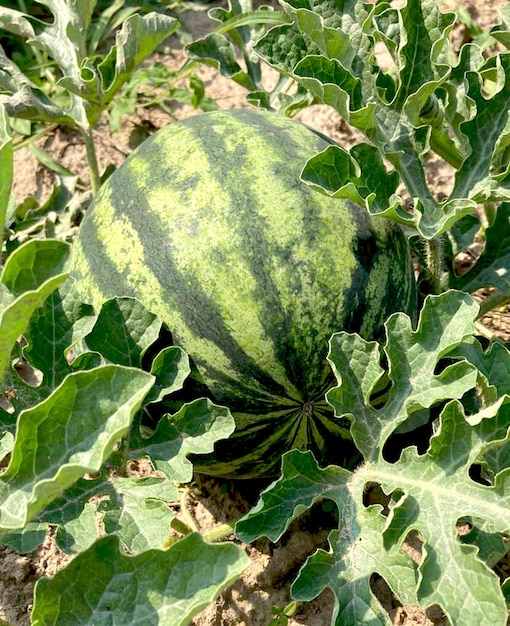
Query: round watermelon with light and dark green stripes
73 109 415 478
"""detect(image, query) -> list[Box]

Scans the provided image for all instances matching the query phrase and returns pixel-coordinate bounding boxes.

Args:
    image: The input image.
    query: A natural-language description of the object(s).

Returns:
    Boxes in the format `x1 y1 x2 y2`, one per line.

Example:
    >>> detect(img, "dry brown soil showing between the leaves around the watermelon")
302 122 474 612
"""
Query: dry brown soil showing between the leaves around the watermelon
0 0 510 626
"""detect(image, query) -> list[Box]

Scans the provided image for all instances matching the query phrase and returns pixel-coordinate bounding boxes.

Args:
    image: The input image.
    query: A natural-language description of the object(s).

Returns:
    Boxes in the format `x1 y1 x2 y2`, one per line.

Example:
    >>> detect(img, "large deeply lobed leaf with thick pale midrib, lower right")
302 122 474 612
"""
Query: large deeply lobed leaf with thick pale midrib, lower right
236 292 510 626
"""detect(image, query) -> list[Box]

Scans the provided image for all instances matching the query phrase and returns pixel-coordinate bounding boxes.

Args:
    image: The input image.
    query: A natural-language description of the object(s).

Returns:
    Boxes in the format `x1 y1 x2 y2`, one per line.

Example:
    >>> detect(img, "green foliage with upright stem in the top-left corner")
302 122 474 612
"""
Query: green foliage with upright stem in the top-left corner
0 0 207 196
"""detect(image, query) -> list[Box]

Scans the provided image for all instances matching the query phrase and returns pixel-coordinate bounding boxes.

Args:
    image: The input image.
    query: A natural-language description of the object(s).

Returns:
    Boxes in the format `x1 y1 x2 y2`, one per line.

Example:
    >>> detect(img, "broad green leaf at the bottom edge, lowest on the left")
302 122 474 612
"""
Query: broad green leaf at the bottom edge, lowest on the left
32 533 249 626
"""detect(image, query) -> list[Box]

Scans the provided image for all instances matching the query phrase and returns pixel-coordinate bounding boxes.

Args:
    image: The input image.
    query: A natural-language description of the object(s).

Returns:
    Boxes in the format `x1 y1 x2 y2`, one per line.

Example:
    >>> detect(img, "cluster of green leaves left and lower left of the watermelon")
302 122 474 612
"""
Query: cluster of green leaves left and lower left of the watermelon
0 120 248 624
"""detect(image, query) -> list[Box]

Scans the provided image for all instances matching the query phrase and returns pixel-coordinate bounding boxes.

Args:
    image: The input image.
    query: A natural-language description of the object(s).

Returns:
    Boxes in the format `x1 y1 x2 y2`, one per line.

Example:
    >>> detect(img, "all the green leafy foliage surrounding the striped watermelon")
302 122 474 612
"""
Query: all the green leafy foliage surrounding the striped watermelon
0 0 510 626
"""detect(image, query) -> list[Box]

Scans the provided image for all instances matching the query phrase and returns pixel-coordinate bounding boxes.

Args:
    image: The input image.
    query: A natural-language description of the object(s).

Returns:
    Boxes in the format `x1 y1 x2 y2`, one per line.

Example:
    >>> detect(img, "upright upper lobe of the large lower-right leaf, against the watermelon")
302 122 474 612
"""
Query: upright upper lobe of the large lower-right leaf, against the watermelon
327 292 478 460
